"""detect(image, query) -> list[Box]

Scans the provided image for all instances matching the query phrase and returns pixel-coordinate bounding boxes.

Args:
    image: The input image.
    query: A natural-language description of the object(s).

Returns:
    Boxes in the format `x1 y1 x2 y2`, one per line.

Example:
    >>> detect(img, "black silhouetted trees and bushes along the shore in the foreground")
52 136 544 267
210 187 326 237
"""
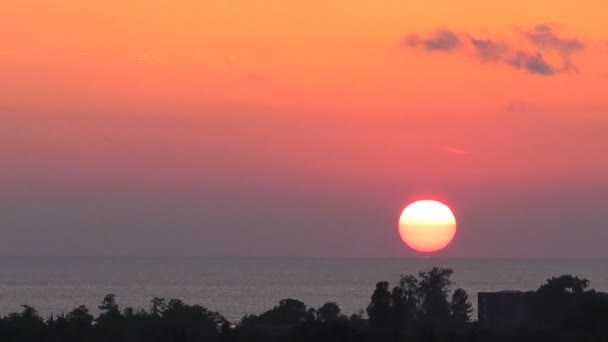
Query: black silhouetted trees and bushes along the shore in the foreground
0 268 608 342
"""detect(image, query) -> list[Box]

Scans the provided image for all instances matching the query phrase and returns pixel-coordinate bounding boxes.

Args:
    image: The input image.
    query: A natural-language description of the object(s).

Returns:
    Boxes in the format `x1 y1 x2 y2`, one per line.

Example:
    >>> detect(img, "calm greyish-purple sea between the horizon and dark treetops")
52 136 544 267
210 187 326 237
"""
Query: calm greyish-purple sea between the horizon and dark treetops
0 258 608 320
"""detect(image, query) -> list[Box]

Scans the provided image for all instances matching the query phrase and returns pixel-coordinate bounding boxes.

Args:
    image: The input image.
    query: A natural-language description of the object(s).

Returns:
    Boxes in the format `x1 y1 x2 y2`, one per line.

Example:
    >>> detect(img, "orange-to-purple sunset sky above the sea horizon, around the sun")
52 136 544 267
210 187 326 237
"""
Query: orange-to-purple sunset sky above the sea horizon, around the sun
0 0 608 258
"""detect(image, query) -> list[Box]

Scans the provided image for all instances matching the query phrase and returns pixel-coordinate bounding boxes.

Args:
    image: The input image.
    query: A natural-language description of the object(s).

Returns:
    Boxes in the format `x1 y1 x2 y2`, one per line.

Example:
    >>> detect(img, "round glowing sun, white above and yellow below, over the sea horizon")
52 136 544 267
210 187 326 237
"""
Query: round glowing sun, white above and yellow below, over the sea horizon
399 200 456 253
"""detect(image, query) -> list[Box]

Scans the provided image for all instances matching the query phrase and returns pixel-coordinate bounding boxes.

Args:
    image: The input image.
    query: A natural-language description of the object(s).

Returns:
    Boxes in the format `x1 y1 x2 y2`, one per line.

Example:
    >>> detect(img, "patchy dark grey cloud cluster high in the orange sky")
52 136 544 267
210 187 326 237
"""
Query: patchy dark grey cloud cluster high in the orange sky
406 25 585 76
